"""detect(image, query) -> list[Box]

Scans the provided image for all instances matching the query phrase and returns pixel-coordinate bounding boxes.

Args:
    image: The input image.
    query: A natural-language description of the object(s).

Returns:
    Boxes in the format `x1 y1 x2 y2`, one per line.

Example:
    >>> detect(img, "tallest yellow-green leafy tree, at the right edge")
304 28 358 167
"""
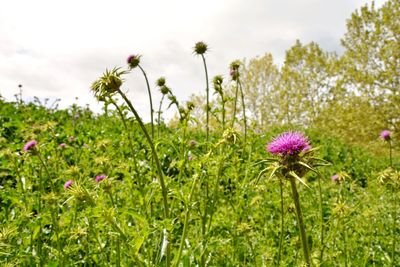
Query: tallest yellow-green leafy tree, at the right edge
342 0 400 130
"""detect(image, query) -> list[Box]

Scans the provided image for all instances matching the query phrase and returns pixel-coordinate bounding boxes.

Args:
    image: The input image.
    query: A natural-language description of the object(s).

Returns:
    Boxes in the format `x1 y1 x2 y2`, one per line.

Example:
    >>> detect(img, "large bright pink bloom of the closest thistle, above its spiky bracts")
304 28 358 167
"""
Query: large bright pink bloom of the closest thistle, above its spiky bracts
267 132 311 156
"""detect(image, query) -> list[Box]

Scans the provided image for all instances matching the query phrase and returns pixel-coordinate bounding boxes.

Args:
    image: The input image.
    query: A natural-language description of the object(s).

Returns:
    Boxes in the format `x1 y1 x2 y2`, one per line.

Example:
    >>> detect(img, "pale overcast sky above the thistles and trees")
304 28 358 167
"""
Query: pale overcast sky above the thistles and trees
0 0 384 119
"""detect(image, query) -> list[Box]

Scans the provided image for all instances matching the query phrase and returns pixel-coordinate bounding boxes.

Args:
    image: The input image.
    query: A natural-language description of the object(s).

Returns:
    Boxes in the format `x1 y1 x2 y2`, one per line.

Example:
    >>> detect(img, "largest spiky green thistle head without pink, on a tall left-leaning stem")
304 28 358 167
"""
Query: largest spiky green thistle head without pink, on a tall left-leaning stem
91 68 126 101
